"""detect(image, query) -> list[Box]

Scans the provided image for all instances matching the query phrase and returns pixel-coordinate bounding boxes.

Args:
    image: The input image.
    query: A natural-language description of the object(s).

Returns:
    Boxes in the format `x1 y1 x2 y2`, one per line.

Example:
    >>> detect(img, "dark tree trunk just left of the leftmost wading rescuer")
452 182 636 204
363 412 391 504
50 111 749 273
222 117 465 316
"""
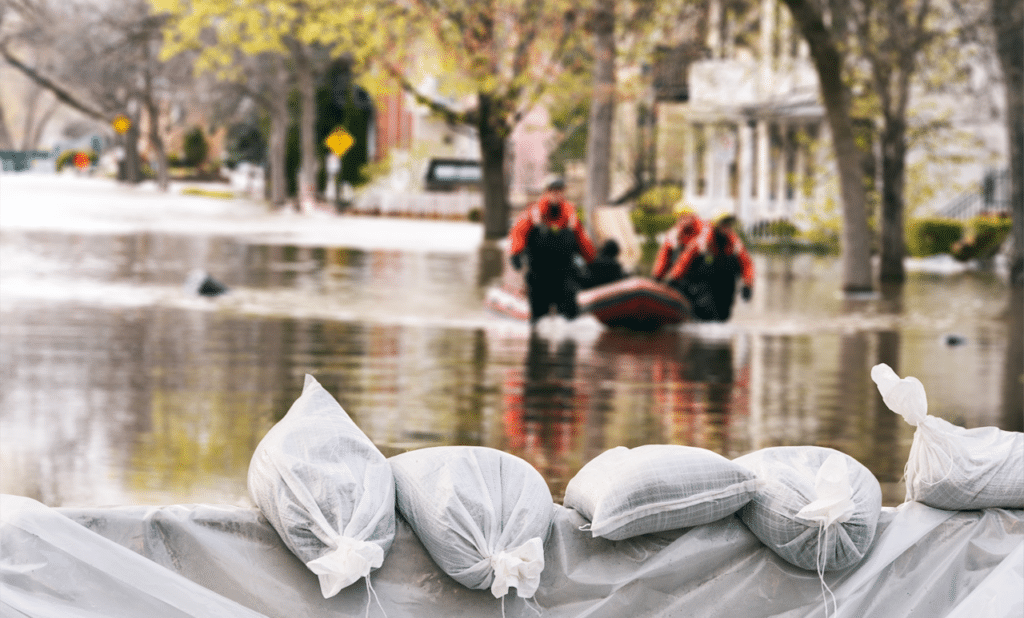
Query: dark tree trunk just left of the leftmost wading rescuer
477 92 509 240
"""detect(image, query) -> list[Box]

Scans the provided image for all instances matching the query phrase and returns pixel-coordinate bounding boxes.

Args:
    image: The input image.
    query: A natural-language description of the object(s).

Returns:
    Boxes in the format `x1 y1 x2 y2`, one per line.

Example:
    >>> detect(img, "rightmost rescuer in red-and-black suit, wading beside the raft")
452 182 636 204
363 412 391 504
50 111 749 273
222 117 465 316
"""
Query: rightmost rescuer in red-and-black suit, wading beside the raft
666 214 754 321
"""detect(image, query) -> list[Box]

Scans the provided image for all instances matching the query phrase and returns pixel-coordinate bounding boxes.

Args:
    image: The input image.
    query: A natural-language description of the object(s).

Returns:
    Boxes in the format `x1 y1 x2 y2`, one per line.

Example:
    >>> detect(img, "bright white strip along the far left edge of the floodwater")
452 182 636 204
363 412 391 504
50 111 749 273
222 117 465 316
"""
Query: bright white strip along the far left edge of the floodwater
0 173 483 253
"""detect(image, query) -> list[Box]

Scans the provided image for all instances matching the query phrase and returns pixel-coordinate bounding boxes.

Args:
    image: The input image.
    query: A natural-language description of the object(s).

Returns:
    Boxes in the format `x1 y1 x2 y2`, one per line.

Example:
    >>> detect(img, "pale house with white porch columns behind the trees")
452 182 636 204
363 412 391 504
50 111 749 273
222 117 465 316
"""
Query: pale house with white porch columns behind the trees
613 0 1007 223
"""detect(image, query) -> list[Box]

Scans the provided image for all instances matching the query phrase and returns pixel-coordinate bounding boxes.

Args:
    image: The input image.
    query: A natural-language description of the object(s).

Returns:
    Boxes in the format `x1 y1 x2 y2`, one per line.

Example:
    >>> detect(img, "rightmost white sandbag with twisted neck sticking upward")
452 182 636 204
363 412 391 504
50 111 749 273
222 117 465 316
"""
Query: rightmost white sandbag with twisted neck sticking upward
871 363 1024 511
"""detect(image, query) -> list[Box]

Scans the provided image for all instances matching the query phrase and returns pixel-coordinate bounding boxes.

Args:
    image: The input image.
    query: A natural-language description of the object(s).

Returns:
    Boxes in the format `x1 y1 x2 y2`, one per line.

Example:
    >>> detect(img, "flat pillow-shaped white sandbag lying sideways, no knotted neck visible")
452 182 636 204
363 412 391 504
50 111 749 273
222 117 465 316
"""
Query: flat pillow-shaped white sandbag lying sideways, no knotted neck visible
562 444 757 540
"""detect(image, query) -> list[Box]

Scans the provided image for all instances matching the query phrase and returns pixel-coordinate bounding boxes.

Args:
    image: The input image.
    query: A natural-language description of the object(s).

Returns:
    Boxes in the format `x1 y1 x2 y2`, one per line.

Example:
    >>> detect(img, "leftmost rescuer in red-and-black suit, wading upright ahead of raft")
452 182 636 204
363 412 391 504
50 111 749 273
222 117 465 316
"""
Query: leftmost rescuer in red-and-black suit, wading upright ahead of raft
509 179 595 323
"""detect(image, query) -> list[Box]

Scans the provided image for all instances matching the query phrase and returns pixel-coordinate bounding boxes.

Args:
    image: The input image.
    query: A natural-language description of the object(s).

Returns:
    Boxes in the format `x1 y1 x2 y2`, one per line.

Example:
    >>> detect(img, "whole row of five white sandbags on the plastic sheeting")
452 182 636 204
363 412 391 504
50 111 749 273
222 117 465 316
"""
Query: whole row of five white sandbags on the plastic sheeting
248 365 1024 598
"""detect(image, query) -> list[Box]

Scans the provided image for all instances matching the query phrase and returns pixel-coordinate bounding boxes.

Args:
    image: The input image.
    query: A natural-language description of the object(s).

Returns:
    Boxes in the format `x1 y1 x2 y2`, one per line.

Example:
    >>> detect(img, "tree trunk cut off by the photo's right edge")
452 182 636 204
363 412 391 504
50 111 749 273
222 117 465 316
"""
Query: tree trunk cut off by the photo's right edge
991 0 1024 288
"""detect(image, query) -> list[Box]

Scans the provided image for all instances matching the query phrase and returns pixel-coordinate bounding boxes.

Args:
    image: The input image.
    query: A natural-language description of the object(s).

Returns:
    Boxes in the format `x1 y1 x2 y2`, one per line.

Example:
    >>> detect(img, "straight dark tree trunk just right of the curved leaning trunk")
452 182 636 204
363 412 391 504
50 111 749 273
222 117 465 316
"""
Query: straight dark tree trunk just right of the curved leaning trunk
879 118 906 282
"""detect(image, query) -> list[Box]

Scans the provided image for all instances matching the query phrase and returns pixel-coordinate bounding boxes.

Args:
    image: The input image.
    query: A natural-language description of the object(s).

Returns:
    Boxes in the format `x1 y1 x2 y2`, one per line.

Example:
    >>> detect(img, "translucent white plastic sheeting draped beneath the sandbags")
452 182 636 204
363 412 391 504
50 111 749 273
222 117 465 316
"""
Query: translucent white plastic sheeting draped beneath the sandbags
0 496 1024 618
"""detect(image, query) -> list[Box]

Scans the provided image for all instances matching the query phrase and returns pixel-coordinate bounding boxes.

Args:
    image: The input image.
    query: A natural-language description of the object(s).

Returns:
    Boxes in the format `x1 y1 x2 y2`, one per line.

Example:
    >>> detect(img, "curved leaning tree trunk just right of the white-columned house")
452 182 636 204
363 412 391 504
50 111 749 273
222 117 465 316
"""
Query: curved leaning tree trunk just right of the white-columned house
782 0 873 293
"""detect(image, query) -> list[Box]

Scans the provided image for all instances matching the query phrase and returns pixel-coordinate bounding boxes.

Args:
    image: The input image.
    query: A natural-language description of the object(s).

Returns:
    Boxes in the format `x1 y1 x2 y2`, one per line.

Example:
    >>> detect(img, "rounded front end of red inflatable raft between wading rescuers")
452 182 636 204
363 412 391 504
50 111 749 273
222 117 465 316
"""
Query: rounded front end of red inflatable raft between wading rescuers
578 277 691 330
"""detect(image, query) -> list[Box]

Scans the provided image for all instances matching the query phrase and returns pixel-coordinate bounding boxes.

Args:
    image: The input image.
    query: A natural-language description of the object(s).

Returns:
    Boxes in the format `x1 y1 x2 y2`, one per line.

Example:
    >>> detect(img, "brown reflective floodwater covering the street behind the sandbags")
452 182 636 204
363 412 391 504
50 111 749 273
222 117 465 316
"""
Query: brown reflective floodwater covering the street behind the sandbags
0 176 1024 506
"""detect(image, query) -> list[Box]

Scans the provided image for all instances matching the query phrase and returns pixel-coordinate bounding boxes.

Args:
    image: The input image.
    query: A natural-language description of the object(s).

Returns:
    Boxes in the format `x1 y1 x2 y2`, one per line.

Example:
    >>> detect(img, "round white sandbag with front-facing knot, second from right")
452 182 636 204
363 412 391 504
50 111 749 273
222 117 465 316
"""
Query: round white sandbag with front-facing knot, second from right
733 446 882 573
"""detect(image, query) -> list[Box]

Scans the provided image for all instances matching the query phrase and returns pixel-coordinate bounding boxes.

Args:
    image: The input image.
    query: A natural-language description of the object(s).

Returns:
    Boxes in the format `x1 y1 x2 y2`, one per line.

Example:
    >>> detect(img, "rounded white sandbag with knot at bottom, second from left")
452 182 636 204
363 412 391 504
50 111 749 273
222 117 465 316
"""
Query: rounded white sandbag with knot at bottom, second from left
388 446 554 599
